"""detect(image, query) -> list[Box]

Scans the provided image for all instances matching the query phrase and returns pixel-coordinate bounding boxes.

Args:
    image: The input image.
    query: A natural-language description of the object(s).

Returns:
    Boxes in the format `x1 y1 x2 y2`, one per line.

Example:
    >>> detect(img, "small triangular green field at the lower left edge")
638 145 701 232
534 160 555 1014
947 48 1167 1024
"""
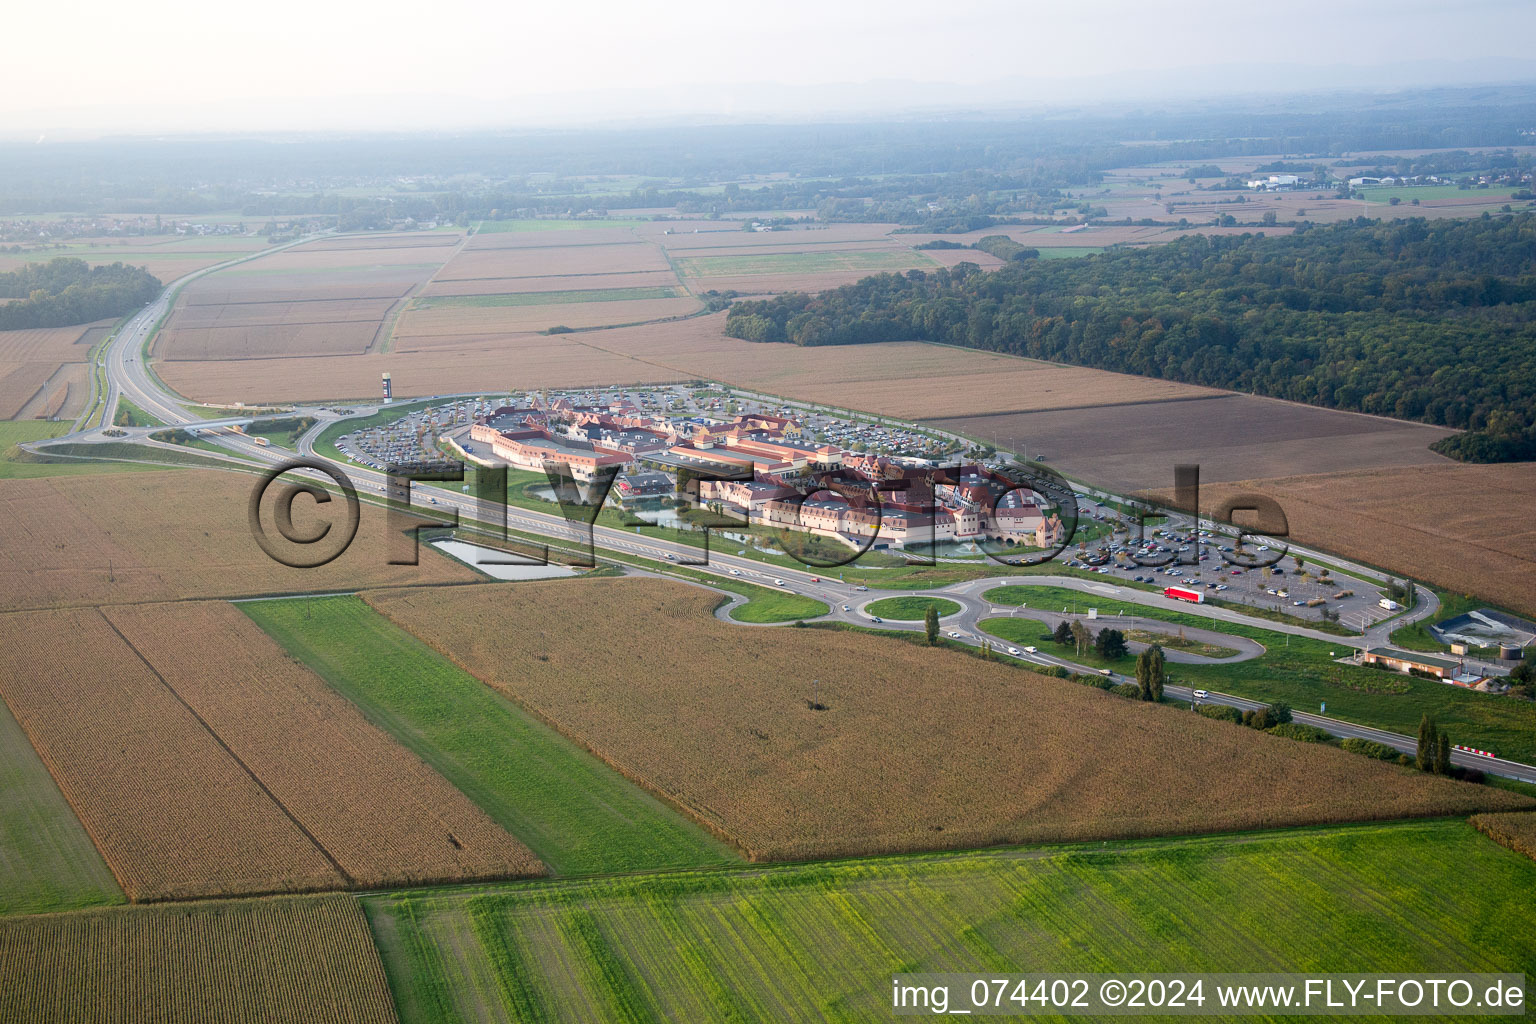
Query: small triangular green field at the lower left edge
0 702 124 915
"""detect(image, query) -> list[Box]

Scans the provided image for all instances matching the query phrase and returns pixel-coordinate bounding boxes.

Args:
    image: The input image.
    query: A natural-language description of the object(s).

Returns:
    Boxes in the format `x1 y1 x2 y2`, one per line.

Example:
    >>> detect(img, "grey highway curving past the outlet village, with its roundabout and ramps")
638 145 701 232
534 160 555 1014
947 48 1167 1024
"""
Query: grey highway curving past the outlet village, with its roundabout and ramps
26 238 1536 783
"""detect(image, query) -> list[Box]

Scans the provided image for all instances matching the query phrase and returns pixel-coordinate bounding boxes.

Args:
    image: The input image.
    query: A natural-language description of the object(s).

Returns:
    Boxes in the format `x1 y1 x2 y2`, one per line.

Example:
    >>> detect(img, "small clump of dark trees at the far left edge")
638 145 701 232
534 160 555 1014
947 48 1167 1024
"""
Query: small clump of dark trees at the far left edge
0 256 161 330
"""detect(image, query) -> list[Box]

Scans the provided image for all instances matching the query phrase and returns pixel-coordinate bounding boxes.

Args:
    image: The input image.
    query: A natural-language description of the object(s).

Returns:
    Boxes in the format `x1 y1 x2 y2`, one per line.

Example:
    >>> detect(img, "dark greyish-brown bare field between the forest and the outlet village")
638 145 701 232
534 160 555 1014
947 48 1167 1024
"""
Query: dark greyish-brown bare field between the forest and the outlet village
928 389 1453 491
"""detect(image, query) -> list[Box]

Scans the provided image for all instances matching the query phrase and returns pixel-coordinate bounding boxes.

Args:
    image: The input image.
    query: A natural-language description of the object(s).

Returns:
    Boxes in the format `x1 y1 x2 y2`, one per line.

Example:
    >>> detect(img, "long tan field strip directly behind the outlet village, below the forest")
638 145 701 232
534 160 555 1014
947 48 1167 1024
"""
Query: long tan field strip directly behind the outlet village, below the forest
160 313 1221 418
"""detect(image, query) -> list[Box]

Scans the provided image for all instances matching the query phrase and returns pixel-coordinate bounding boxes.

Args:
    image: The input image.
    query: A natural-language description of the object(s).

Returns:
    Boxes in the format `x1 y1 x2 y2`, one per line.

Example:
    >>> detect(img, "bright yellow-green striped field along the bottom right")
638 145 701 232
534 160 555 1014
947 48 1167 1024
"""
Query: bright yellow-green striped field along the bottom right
364 821 1536 1024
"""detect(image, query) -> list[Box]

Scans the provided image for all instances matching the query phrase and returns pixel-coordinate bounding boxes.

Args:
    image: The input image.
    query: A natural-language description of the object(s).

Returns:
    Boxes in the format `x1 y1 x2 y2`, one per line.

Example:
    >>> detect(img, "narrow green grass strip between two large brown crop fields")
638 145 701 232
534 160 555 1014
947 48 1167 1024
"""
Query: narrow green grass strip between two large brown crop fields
240 597 736 875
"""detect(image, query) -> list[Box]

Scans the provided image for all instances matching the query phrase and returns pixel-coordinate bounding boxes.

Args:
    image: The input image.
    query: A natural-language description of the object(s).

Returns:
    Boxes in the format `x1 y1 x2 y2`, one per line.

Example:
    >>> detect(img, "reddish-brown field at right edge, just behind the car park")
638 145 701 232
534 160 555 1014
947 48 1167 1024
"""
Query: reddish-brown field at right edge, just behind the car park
1191 456 1536 616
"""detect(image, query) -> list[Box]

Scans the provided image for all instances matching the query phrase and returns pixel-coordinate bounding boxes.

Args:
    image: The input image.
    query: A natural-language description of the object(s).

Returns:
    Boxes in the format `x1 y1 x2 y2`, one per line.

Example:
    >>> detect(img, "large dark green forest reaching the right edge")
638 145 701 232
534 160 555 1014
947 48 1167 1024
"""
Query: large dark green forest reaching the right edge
727 213 1536 462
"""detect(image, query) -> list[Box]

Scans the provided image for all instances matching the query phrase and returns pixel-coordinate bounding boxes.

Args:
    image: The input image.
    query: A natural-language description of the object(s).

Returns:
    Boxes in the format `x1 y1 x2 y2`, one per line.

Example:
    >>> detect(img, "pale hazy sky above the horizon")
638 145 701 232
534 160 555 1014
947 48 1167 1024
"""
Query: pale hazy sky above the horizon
9 0 1536 137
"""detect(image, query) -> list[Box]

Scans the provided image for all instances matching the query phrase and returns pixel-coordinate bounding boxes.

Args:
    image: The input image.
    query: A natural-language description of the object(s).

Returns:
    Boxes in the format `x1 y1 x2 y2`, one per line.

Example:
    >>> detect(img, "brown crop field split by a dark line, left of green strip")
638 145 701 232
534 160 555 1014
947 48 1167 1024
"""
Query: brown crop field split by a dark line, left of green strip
0 602 542 900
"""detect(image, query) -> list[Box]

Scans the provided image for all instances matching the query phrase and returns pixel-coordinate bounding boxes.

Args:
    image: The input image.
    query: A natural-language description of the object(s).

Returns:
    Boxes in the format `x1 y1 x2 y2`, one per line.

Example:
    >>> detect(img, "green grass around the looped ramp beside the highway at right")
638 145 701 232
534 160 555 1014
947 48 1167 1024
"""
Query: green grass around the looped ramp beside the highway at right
983 586 1536 763
